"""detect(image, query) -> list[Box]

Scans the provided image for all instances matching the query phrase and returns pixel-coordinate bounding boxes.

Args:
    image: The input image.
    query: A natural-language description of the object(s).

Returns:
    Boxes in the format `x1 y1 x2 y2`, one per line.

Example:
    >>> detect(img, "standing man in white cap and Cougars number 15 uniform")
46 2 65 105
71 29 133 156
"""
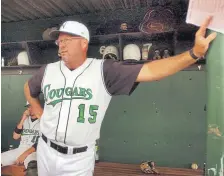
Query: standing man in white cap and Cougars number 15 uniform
24 17 216 176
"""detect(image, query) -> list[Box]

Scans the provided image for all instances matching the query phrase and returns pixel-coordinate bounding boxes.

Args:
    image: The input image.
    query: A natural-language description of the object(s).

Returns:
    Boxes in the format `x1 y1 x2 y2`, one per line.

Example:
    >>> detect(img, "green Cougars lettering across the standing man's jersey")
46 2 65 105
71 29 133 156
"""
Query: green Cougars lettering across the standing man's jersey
44 84 93 106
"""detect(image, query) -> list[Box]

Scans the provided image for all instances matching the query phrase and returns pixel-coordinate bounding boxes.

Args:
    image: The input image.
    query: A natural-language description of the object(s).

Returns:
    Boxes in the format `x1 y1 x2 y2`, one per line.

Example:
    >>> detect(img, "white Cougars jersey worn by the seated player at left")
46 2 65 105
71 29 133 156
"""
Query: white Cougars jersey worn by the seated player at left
19 117 40 147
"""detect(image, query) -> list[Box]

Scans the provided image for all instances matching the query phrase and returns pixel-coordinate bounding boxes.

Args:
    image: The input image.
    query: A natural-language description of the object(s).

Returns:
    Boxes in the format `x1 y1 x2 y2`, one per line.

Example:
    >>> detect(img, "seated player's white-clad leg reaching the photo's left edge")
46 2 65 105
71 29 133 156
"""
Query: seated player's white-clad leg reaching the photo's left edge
1 148 27 166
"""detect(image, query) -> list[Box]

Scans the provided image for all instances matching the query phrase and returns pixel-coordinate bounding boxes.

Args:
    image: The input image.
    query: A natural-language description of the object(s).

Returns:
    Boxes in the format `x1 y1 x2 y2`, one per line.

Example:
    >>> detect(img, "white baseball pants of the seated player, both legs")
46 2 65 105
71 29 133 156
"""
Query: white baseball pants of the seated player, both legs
1 146 37 168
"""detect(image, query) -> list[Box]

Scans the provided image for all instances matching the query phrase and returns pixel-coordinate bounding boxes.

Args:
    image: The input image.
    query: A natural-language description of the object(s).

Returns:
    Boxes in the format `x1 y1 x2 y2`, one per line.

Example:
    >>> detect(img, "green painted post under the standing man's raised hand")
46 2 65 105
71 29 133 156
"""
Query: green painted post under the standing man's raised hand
205 31 224 176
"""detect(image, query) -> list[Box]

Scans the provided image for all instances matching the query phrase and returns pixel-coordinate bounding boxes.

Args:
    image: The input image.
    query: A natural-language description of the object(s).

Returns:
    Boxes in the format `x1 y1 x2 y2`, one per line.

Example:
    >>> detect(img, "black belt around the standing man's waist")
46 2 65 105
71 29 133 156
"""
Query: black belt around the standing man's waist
42 134 88 154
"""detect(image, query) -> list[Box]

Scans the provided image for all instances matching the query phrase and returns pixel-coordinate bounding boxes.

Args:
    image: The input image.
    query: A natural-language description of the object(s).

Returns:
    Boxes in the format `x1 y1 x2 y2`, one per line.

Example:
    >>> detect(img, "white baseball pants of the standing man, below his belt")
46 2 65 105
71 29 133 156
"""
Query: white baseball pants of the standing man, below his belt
37 137 95 176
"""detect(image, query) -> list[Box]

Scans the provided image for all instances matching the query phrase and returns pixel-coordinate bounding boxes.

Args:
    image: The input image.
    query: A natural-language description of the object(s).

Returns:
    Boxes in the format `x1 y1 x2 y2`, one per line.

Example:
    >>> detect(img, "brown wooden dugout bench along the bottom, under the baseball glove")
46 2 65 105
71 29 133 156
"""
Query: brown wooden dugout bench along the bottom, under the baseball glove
2 162 203 176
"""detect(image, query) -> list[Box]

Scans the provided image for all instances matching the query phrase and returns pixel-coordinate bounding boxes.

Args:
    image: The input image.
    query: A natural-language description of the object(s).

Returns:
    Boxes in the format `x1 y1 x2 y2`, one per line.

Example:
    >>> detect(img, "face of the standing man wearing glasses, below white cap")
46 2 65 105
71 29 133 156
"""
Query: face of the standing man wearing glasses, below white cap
56 33 88 65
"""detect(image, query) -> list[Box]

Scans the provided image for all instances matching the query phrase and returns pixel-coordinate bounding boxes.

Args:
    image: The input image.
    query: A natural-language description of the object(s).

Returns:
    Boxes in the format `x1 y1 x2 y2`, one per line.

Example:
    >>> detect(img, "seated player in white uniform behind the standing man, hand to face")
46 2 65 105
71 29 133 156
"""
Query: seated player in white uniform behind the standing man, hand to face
1 104 40 168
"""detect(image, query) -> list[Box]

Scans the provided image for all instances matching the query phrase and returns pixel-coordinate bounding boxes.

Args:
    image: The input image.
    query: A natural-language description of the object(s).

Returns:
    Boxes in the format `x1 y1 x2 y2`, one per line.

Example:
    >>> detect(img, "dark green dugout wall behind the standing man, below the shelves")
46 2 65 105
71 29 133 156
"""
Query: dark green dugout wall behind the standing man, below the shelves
1 71 207 167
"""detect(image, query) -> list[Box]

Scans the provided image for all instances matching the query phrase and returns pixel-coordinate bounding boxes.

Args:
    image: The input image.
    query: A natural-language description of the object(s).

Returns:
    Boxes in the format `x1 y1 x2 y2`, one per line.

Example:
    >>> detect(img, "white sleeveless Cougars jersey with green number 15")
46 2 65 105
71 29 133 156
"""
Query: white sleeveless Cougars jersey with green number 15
40 58 111 147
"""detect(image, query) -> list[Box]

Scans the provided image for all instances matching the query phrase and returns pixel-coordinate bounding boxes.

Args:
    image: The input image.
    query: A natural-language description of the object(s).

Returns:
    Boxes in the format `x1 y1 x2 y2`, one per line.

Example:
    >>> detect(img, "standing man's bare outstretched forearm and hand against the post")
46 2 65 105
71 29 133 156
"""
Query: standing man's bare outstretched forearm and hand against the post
136 17 216 82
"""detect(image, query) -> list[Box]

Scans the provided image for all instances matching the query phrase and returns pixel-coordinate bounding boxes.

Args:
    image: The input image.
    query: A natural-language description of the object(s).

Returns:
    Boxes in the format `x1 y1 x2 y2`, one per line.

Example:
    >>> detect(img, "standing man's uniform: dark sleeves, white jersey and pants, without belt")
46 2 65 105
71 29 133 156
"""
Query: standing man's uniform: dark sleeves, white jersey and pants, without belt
28 58 142 176
